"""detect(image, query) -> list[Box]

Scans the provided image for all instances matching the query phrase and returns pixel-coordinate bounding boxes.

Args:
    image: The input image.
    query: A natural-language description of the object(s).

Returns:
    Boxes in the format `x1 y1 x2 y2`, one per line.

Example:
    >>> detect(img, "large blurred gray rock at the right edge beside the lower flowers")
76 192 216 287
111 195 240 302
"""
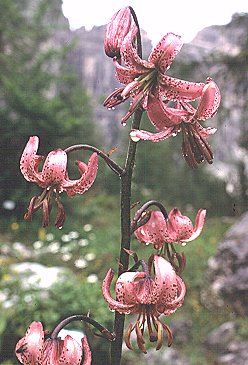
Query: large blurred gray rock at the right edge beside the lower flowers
202 213 248 314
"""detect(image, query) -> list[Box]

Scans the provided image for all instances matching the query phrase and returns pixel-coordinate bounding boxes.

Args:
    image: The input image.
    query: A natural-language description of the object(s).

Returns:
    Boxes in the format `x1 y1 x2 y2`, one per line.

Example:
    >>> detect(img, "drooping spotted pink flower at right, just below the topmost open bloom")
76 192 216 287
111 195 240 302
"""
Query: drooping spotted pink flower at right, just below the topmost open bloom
130 78 221 168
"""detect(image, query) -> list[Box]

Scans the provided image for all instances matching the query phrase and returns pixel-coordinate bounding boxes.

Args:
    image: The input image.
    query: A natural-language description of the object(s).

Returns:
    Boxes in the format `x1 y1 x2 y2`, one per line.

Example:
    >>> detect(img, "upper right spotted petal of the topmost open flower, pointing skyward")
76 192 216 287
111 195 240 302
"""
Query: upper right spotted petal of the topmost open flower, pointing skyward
148 33 183 72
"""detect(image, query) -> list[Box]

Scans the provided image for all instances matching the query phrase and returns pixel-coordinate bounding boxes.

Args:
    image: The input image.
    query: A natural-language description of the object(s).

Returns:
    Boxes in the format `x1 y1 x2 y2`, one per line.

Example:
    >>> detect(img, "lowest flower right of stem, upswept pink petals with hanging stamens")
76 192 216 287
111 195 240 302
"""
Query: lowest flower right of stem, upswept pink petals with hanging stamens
102 256 186 353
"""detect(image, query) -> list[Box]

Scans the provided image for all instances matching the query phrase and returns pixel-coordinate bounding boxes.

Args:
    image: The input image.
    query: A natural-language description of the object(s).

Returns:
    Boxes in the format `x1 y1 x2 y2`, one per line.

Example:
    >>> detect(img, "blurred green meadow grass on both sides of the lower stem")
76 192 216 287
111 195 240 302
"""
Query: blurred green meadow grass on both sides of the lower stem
0 195 241 365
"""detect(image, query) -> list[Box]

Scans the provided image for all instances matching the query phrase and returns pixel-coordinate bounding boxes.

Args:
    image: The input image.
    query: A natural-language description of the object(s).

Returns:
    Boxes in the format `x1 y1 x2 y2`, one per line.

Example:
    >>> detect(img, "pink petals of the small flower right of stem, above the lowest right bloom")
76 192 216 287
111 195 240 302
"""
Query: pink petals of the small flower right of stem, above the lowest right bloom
134 208 206 250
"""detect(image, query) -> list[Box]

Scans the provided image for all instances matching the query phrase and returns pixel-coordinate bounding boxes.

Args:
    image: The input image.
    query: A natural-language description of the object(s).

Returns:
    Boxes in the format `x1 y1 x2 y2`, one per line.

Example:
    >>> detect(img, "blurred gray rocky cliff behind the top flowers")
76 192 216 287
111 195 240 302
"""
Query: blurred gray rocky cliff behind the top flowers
57 14 248 202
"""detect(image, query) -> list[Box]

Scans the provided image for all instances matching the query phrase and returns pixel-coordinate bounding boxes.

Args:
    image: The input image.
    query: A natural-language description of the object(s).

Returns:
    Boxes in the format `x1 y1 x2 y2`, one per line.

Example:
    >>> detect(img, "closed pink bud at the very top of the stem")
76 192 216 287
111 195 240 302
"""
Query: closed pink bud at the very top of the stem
104 6 137 58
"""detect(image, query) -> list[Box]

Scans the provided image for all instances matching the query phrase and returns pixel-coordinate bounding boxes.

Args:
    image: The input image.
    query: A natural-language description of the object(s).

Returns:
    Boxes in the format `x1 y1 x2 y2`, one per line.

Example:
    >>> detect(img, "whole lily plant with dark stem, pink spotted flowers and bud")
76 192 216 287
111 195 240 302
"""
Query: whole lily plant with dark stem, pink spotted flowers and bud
16 7 220 365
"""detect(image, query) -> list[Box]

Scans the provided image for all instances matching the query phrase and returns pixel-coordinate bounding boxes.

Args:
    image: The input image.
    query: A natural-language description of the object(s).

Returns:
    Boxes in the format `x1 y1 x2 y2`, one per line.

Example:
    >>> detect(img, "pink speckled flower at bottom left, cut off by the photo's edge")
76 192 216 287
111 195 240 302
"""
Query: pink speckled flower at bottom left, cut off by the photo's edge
15 322 91 365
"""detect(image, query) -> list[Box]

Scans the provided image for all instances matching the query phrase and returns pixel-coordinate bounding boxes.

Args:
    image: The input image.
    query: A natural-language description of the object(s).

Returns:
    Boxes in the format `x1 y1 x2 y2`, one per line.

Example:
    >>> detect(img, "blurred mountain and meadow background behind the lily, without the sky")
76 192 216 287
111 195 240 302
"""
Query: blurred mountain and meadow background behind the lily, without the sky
0 0 248 365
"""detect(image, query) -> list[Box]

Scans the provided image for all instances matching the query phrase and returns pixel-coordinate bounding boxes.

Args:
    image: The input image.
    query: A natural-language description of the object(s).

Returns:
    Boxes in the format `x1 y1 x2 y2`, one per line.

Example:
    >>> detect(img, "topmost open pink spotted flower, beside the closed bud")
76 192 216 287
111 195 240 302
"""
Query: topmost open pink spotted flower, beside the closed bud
104 32 208 123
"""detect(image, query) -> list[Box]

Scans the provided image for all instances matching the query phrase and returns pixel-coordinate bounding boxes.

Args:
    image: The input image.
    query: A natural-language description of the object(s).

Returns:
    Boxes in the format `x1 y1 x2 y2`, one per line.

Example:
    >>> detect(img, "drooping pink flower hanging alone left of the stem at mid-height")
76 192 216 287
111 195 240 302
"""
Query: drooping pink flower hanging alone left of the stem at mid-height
20 136 98 228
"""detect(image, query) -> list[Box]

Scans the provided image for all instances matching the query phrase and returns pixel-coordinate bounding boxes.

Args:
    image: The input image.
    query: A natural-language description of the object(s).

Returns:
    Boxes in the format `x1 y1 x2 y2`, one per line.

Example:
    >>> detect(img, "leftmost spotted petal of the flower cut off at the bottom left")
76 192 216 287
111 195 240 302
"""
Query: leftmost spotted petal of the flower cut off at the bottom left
15 322 44 365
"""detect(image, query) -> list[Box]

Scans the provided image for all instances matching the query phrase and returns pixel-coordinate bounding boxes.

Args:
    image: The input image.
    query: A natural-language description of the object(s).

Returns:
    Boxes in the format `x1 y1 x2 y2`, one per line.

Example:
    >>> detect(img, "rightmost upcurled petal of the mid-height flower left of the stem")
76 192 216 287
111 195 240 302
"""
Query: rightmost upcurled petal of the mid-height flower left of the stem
61 152 98 196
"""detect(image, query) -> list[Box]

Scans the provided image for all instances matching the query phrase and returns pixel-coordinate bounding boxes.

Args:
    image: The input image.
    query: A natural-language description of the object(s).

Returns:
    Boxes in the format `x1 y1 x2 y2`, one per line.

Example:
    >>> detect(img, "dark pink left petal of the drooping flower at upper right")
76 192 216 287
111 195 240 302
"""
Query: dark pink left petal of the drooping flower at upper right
147 95 193 130
